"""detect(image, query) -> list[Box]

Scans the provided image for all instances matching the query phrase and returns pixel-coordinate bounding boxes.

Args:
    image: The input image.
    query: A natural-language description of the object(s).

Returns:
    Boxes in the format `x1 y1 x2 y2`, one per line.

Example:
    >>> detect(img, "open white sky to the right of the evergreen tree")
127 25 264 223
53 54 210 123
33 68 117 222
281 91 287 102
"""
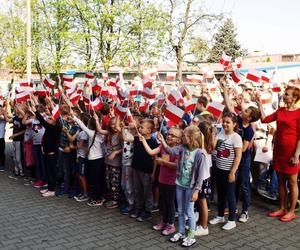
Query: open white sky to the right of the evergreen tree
206 0 300 54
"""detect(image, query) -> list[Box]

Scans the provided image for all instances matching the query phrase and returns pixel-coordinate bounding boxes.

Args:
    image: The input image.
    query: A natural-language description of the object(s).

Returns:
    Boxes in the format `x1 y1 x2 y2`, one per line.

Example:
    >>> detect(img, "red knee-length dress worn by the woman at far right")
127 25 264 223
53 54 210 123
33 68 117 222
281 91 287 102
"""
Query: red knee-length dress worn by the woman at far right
263 108 300 174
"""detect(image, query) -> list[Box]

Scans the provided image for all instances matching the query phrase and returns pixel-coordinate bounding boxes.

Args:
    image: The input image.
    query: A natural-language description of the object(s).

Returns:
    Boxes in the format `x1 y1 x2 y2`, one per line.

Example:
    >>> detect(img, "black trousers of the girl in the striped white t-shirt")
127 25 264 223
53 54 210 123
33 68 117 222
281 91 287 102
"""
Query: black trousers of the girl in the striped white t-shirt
216 168 236 221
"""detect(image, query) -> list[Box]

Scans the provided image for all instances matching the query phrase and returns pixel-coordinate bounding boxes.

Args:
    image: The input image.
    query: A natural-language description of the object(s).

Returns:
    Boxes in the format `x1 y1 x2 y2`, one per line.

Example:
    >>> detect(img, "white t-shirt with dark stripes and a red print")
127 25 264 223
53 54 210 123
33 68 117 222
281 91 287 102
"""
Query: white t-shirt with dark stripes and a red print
216 130 243 171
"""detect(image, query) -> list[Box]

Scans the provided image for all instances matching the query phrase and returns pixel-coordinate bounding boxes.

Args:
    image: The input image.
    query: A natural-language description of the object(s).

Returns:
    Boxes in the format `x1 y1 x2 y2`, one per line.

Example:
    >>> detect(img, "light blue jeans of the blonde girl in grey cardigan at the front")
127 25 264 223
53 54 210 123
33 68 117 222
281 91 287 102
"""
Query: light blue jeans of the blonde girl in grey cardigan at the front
176 185 196 235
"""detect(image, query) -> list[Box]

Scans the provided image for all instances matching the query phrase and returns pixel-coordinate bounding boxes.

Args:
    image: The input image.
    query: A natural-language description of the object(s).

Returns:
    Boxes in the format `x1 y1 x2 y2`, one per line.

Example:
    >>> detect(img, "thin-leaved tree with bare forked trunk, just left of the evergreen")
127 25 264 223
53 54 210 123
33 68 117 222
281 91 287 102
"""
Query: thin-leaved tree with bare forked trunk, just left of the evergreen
168 0 221 85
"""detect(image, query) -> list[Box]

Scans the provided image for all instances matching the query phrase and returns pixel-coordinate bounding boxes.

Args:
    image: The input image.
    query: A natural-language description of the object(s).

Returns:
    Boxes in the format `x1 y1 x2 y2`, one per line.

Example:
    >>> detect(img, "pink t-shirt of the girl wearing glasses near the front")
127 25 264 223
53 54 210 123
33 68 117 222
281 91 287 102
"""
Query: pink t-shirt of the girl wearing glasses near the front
158 147 179 185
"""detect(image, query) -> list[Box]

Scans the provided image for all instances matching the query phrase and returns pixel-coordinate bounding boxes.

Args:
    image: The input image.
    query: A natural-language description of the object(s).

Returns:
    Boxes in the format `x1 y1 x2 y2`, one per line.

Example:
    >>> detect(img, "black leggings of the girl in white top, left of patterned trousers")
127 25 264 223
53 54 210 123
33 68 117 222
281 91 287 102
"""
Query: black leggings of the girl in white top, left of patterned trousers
87 158 106 200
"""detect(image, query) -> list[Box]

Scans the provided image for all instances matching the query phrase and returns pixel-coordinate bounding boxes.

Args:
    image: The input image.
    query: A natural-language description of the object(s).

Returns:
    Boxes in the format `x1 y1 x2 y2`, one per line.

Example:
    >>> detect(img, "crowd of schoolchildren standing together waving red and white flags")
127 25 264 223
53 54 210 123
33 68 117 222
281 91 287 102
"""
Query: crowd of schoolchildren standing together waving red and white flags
0 73 300 247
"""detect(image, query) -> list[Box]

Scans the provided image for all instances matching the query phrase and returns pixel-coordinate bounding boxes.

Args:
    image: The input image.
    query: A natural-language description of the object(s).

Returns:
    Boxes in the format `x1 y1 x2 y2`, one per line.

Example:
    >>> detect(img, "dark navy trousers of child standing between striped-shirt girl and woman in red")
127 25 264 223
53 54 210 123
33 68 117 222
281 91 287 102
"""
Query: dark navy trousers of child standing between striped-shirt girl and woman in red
235 154 251 212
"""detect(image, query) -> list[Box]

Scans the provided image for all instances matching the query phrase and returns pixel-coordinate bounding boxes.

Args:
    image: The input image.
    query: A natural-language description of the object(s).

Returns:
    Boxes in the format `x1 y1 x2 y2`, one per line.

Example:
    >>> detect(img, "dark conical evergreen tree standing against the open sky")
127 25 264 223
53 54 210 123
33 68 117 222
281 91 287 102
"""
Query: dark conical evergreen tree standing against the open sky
208 18 247 63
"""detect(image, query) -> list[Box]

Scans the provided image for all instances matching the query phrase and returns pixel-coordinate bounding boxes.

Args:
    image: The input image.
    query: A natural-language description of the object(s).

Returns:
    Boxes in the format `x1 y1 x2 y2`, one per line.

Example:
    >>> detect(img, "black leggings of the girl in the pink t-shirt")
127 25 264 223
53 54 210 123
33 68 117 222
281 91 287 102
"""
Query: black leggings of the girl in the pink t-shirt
159 183 176 224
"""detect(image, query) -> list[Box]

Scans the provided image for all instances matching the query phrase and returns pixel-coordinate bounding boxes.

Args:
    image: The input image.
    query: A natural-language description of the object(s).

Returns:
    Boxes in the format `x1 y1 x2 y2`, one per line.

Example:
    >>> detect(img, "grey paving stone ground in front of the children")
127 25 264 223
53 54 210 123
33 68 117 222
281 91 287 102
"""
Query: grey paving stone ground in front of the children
0 144 300 250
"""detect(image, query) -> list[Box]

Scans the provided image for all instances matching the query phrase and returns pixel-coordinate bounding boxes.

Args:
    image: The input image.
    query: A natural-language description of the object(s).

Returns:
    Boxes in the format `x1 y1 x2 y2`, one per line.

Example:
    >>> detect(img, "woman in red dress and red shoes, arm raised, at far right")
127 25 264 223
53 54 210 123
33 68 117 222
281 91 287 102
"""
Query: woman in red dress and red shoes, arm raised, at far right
259 86 300 222
